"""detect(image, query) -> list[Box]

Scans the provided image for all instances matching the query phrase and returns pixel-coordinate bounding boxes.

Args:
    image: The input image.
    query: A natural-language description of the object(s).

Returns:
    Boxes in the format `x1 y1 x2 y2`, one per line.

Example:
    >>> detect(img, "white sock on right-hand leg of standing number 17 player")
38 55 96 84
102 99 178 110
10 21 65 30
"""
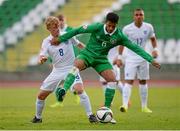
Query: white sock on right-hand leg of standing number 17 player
139 84 148 108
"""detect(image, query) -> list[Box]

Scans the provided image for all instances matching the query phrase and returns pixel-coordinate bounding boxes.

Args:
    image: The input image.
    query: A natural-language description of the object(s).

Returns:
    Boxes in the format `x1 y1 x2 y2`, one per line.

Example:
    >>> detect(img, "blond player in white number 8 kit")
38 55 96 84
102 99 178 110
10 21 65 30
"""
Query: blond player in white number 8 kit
31 16 98 123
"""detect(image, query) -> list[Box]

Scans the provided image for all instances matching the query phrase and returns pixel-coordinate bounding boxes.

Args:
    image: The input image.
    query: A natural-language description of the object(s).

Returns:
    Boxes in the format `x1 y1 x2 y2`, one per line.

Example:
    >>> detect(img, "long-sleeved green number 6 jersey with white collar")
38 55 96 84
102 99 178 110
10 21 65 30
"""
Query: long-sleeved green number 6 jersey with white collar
59 23 153 63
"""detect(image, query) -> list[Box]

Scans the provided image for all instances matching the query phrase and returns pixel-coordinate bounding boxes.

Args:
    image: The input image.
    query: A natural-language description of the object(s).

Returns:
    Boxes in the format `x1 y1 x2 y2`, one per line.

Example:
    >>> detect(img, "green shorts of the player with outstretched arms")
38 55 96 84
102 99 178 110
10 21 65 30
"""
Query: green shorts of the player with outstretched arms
77 50 113 73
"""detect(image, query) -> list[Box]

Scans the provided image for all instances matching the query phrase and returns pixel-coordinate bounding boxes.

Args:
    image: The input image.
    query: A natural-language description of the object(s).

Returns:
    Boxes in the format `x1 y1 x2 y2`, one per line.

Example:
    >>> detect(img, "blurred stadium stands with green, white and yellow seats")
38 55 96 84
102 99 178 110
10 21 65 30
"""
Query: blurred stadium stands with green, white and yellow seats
0 0 180 81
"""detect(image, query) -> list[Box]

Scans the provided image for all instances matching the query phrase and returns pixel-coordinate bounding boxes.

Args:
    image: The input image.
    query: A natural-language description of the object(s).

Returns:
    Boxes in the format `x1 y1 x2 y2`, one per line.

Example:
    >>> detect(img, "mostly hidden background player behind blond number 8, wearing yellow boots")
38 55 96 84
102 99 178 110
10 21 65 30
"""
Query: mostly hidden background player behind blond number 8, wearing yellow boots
50 14 83 108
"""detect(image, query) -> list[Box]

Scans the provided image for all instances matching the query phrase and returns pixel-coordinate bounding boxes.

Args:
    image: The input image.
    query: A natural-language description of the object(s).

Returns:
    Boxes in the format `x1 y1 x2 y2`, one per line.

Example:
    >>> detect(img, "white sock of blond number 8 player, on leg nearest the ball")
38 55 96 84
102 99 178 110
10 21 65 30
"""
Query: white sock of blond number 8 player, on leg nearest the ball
79 91 93 117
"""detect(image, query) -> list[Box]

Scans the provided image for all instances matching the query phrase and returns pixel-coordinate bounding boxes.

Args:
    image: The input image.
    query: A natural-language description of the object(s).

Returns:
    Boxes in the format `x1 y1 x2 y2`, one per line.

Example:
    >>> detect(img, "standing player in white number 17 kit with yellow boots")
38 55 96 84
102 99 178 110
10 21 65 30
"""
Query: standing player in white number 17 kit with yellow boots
120 9 158 113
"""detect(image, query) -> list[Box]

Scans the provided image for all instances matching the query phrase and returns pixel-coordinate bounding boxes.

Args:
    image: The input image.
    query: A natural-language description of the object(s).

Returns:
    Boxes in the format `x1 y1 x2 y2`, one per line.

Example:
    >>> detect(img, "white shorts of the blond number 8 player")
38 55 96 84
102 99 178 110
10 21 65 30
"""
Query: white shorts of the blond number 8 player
40 70 83 91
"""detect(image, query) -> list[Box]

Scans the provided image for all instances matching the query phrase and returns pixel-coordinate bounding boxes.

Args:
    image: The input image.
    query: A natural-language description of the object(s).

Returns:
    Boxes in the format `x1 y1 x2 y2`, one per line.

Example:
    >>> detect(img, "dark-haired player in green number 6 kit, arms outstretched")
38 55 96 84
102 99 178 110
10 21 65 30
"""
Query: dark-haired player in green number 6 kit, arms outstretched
51 12 160 123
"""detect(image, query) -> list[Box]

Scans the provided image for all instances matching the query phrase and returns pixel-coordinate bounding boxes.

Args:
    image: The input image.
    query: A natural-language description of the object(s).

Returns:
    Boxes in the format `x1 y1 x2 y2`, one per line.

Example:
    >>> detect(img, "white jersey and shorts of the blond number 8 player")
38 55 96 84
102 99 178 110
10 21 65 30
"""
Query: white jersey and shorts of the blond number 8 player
40 32 82 91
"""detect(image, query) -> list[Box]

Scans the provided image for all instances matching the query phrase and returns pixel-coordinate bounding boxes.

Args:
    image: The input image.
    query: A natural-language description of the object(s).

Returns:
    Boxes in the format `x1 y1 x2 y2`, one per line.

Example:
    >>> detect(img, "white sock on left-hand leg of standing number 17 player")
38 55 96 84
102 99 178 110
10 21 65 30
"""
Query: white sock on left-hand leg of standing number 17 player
122 83 132 108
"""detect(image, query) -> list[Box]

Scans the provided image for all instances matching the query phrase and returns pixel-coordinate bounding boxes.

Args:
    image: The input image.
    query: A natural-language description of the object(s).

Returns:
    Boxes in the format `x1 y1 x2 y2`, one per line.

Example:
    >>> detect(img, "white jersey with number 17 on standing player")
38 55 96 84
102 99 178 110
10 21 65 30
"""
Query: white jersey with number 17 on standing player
123 22 155 62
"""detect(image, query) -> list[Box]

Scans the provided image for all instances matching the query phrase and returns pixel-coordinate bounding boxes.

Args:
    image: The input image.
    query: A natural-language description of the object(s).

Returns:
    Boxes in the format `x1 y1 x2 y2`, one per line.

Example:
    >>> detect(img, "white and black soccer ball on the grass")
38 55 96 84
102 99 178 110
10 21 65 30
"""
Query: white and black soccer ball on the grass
96 107 113 123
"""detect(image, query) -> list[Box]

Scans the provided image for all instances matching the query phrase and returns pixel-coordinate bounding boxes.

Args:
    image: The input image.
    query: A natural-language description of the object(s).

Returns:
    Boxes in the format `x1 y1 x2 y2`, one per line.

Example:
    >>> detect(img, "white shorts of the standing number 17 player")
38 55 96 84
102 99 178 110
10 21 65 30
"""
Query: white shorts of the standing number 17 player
124 61 149 80
